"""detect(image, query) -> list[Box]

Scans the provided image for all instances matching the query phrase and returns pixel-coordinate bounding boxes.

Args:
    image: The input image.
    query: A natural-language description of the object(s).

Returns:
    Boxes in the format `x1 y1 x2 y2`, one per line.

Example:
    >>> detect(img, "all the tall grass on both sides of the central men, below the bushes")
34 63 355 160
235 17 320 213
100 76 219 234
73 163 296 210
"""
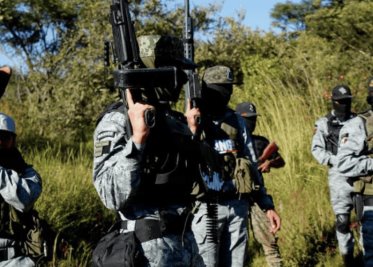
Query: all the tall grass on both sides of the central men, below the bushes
5 76 364 267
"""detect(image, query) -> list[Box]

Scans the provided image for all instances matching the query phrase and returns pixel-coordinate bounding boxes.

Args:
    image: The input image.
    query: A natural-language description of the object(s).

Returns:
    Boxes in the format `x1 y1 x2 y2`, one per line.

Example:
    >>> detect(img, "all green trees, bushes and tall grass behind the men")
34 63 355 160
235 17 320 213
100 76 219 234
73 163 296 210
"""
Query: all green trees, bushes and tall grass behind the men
0 0 373 266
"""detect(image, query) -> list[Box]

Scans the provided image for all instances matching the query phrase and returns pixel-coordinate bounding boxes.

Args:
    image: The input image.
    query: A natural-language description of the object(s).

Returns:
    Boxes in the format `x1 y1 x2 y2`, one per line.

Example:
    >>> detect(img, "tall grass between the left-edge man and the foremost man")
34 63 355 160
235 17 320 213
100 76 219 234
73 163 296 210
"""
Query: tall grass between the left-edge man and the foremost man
20 140 114 267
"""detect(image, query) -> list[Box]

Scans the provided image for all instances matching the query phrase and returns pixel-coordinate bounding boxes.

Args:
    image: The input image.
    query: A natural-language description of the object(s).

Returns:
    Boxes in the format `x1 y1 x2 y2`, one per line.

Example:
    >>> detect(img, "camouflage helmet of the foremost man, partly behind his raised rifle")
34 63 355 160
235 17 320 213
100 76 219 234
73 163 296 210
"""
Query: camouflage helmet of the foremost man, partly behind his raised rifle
137 35 196 69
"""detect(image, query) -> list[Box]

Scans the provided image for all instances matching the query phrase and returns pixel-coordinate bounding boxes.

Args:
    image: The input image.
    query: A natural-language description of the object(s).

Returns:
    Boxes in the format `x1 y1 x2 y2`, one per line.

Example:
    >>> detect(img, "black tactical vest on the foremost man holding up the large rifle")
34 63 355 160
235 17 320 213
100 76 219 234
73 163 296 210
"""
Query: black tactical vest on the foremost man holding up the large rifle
97 102 203 210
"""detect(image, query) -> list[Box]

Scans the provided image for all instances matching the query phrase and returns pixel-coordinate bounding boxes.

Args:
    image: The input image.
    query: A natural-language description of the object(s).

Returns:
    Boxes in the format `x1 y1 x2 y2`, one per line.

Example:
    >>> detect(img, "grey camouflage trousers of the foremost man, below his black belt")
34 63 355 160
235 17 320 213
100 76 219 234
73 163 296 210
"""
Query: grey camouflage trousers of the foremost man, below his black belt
141 231 205 267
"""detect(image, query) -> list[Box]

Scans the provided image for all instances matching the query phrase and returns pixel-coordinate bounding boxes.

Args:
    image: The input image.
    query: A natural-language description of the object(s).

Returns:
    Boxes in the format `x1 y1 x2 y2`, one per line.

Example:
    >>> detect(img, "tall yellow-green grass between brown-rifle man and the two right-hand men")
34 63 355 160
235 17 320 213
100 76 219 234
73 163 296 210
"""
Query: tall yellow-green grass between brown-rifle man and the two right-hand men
232 68 360 267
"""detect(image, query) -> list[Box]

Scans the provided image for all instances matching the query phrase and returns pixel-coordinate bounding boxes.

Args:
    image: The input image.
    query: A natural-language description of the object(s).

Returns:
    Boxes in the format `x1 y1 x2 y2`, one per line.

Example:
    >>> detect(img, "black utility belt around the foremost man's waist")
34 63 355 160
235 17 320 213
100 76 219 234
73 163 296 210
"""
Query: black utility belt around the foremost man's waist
120 212 192 243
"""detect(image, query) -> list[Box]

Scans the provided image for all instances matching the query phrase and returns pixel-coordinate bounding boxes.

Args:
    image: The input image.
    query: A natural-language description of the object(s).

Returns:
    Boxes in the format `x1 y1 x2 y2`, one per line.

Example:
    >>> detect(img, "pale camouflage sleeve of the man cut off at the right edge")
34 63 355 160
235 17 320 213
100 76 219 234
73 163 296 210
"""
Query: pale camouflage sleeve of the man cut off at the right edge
337 117 373 177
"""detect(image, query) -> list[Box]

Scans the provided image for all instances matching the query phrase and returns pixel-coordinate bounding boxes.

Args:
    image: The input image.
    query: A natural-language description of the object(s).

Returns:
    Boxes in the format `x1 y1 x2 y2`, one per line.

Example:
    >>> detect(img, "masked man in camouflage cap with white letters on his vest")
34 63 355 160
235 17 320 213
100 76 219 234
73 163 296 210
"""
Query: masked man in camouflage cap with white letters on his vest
192 65 280 267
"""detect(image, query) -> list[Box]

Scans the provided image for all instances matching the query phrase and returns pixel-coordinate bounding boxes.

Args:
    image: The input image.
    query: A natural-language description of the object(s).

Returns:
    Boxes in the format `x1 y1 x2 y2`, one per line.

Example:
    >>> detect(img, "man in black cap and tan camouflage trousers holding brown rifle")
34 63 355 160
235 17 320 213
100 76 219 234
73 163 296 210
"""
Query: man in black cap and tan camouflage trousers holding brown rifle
236 102 285 267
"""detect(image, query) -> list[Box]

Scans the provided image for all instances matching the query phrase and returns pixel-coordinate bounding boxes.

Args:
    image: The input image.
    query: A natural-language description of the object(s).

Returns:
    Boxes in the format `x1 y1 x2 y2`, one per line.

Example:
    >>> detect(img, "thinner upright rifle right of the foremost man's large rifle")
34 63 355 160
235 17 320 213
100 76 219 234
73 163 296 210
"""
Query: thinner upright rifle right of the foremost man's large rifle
183 0 201 119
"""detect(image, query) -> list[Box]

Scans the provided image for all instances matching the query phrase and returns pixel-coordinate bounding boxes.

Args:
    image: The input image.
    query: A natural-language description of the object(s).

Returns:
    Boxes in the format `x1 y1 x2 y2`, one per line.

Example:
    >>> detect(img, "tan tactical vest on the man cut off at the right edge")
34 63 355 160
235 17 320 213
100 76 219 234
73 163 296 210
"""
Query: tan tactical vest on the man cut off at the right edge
354 110 373 195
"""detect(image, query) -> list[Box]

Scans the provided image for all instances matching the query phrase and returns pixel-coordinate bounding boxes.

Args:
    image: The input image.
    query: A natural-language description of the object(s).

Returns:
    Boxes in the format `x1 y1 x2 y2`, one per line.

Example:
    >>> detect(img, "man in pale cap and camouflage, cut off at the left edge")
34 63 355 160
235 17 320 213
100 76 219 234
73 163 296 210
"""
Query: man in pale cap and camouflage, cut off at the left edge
0 113 42 267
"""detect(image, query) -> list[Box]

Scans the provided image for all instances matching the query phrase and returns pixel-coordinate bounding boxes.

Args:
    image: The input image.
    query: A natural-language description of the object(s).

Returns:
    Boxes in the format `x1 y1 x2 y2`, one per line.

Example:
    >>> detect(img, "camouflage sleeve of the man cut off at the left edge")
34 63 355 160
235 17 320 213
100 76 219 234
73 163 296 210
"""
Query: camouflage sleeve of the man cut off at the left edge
0 166 42 212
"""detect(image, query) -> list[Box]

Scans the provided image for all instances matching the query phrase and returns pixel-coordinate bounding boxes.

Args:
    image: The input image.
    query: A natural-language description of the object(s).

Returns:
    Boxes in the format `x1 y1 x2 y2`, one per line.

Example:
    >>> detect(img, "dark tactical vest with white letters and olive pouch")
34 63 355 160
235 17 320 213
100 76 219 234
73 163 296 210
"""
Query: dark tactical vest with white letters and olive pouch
203 110 256 193
